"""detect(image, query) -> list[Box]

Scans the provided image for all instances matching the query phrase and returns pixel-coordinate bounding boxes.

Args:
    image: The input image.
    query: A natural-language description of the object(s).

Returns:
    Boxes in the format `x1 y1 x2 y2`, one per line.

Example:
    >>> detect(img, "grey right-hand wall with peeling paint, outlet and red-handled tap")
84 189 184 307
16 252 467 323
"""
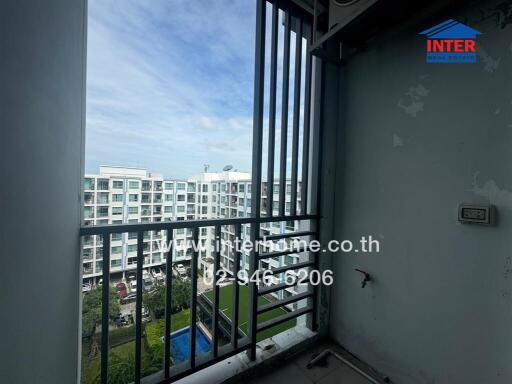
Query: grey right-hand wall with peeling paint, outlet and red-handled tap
330 2 512 384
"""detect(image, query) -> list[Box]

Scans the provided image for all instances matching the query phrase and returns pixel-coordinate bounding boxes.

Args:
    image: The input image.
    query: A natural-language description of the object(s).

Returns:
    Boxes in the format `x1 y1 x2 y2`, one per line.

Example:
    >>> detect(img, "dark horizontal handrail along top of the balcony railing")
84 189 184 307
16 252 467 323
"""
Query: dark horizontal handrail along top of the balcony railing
80 215 318 236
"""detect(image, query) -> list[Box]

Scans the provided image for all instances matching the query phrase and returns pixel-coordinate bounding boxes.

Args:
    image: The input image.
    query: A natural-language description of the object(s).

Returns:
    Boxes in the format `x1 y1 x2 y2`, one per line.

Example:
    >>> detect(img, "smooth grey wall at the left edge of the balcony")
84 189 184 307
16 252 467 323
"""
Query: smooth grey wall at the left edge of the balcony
0 0 85 384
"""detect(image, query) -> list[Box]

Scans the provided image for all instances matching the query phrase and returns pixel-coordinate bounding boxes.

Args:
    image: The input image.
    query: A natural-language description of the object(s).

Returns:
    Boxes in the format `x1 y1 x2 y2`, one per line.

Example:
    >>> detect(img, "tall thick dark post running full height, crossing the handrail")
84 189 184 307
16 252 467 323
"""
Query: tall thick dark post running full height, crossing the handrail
249 0 267 361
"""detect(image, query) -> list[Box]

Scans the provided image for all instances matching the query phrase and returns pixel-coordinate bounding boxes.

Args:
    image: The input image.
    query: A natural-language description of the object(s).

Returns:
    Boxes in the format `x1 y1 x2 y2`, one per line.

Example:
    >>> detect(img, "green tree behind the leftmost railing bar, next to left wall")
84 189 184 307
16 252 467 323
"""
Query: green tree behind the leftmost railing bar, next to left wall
82 287 119 333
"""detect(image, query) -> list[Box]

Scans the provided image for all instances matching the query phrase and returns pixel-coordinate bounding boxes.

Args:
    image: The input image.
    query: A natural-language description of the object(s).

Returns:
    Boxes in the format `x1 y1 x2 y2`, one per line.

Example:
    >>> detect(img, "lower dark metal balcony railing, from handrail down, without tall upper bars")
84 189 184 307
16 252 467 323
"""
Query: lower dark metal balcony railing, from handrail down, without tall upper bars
81 215 318 384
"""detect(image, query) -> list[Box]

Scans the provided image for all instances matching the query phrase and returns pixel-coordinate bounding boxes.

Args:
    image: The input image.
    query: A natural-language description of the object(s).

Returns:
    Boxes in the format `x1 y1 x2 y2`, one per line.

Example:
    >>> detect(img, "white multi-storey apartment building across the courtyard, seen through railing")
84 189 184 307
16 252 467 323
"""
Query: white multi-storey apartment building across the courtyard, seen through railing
82 166 300 300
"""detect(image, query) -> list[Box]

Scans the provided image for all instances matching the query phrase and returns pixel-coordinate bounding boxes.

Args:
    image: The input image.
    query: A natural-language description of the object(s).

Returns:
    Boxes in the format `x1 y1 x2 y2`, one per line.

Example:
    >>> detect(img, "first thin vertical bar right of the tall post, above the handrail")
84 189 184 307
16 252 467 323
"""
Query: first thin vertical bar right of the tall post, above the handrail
267 3 279 217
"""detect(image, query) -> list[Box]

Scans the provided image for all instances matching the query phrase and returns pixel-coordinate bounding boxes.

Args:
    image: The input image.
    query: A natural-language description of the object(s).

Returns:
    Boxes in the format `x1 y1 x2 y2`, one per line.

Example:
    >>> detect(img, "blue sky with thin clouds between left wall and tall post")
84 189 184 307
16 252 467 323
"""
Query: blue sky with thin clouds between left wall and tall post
86 0 255 178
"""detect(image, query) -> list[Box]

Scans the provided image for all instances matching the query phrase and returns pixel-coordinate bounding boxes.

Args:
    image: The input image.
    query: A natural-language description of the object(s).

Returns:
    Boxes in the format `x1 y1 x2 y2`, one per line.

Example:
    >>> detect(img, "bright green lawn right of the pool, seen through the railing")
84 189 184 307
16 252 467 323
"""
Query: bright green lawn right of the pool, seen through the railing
204 284 296 341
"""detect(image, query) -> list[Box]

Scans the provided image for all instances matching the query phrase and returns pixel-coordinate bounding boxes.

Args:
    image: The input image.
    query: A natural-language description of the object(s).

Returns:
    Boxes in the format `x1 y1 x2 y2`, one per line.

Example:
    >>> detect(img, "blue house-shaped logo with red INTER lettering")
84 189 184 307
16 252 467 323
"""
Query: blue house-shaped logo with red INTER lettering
420 19 481 63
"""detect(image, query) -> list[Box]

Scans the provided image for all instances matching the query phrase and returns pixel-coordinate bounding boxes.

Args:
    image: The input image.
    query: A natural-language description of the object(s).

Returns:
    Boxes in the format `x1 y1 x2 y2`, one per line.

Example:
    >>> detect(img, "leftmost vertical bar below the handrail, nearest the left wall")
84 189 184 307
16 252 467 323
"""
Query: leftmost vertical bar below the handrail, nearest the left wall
101 233 110 384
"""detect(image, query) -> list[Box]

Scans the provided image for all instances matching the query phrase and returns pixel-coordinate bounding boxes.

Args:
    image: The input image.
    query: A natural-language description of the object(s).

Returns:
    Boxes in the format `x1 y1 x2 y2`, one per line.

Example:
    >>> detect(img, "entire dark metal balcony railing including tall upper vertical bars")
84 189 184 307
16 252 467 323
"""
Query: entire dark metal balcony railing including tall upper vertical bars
81 0 319 384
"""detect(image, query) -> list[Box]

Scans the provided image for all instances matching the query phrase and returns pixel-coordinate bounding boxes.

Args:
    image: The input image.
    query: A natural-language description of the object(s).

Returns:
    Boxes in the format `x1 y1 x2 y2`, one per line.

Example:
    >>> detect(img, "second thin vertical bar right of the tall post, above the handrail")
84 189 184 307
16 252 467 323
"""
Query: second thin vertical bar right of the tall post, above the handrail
279 12 290 216
